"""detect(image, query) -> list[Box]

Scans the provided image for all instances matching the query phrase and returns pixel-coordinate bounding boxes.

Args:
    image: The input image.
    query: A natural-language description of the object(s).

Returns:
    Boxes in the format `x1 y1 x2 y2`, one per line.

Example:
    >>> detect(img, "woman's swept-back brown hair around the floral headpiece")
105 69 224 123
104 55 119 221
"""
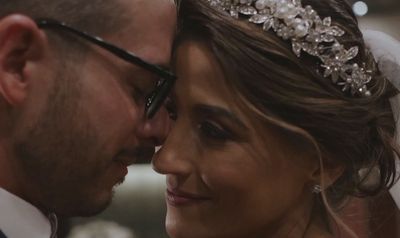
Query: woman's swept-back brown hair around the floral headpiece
176 0 399 208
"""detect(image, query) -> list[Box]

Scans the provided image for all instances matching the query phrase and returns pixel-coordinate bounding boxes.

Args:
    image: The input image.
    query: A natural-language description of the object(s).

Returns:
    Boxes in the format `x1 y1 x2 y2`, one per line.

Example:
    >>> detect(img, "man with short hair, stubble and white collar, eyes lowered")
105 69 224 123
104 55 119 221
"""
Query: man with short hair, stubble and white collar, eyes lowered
0 0 176 238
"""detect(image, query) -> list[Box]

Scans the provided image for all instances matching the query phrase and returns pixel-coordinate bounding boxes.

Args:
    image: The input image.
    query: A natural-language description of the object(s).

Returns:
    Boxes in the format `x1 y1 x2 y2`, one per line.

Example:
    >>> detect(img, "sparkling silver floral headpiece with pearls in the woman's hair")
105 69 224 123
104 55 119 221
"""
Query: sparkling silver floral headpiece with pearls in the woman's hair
207 0 372 97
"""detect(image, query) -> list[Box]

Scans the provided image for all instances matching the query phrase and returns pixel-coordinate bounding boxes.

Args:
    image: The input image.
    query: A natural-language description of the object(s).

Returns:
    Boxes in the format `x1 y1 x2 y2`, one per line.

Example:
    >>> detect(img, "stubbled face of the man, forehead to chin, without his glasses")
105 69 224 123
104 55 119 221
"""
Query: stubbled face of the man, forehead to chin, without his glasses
10 0 176 216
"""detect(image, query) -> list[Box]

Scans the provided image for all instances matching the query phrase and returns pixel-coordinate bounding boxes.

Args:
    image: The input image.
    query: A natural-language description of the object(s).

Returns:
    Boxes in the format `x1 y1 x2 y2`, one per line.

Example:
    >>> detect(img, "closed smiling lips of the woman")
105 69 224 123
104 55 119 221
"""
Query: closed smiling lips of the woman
166 189 211 206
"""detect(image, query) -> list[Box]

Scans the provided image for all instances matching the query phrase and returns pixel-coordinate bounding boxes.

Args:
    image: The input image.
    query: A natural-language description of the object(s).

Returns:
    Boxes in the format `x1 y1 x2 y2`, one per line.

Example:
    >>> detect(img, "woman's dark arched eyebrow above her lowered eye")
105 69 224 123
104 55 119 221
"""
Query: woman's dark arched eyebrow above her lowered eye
194 104 248 130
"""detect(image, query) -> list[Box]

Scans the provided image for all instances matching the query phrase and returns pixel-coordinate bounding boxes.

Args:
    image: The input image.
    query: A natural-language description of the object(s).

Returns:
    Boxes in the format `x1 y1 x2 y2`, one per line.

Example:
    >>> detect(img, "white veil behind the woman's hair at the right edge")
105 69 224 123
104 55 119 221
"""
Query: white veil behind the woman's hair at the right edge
363 30 400 209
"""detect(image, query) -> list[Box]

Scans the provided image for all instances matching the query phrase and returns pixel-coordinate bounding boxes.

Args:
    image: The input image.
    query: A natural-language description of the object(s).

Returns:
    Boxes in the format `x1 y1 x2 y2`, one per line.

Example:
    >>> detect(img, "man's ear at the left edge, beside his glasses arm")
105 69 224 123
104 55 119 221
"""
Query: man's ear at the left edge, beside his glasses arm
0 14 46 106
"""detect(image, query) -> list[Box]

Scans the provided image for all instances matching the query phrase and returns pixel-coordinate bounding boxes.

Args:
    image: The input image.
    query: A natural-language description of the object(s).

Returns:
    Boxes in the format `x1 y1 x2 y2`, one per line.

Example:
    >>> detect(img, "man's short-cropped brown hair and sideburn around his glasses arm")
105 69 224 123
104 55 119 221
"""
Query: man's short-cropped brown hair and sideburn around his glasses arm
0 0 127 59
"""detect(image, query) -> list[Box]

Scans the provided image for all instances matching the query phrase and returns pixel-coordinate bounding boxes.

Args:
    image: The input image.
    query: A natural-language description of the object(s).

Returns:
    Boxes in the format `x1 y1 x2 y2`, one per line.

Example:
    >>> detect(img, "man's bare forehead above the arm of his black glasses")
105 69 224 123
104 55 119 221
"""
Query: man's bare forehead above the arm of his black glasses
111 0 176 65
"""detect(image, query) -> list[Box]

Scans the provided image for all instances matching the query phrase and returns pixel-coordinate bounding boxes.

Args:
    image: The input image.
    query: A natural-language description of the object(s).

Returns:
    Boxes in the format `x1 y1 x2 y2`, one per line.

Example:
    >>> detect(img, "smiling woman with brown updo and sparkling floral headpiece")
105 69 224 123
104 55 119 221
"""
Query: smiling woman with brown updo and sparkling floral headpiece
153 0 399 238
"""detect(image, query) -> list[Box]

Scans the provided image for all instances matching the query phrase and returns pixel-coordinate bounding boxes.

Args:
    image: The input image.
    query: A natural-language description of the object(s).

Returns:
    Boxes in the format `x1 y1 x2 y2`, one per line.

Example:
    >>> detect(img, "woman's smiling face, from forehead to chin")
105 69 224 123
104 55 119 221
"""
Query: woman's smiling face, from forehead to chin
153 41 311 238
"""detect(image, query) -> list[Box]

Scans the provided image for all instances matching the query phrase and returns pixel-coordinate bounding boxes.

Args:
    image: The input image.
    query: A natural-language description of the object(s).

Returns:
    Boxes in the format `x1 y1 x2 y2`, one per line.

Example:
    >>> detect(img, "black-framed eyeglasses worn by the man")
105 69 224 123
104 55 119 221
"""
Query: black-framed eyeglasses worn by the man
35 18 176 118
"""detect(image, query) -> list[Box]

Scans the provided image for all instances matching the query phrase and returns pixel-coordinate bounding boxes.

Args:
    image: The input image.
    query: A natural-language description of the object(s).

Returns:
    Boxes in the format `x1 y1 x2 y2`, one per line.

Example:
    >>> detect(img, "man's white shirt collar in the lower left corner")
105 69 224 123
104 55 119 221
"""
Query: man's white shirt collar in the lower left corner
0 187 51 238
